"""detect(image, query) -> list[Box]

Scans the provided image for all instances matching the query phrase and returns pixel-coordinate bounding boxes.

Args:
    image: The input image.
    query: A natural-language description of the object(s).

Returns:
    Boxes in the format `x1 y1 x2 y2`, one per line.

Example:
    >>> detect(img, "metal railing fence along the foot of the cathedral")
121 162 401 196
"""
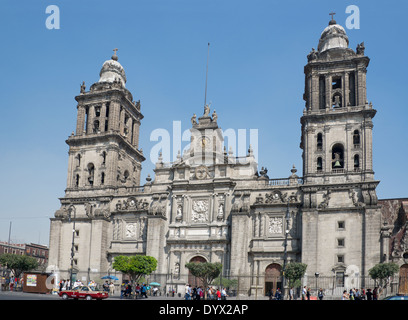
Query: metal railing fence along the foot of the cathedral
42 270 399 300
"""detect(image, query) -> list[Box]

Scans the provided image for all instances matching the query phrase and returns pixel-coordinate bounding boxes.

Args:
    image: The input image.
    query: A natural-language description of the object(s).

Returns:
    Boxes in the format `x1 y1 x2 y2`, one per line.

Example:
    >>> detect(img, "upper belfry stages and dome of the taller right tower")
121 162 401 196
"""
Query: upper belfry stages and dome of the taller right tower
300 18 376 183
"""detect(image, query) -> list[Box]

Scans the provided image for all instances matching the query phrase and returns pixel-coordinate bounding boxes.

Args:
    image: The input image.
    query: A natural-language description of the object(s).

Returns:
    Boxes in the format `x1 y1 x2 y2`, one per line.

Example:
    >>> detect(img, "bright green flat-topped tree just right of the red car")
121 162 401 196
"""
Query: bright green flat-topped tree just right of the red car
112 255 157 298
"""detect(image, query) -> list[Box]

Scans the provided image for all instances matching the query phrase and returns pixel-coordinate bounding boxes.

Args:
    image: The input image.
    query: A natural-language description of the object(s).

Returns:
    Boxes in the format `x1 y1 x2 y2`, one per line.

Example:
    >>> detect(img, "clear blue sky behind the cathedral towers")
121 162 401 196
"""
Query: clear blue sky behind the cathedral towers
0 0 408 244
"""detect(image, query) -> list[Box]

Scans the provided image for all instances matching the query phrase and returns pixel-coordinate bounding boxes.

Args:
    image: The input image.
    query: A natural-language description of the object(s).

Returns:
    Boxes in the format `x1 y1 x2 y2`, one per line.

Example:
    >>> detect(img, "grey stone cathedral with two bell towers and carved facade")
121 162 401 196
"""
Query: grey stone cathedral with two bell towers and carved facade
49 18 408 296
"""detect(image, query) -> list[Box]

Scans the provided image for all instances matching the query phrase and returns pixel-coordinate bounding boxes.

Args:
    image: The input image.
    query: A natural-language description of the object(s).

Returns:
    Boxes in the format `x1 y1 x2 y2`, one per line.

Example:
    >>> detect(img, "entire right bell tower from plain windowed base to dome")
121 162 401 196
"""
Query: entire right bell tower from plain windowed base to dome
300 17 381 280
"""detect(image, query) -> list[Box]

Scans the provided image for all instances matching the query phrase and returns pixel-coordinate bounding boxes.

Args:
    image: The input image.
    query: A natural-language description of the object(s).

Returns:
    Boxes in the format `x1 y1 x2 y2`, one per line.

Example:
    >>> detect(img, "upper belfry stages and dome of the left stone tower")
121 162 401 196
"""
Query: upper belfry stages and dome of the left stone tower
66 49 145 193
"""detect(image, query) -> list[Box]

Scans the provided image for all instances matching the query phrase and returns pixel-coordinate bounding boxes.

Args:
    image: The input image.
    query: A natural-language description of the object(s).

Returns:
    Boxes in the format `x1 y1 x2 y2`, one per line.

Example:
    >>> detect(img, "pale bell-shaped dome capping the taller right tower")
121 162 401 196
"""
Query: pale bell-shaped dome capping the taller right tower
317 20 349 52
